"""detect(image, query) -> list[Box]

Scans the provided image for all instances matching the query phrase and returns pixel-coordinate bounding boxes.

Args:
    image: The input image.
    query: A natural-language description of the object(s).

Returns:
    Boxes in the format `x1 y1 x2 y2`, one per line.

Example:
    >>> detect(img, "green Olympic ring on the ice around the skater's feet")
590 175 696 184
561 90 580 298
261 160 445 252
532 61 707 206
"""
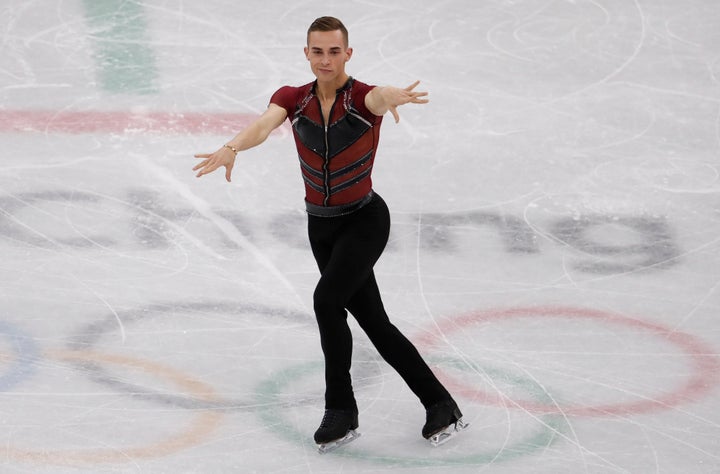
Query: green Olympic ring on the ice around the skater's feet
256 359 567 467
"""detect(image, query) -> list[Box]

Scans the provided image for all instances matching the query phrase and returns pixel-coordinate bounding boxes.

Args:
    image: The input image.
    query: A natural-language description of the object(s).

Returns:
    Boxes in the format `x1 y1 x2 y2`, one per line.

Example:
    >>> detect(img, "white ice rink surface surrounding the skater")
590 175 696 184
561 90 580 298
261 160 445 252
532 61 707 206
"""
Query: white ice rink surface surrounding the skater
0 0 720 474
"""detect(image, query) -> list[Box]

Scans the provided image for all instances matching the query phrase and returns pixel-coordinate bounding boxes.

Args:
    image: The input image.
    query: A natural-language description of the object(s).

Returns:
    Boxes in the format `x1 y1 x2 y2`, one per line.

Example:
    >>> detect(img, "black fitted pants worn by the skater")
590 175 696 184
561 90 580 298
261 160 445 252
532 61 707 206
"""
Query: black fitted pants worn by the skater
308 194 450 410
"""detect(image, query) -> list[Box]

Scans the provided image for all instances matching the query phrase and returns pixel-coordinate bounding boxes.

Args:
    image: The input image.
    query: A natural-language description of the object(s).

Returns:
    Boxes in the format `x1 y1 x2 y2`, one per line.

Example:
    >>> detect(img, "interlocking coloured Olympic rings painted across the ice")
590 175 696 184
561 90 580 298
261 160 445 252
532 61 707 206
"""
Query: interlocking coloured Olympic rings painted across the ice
5 303 720 467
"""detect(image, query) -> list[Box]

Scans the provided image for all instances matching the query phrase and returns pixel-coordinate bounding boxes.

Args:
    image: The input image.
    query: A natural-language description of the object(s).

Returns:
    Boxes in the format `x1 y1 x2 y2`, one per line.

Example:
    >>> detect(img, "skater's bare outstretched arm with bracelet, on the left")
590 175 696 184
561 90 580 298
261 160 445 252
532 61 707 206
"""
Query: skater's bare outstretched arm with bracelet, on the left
193 104 287 182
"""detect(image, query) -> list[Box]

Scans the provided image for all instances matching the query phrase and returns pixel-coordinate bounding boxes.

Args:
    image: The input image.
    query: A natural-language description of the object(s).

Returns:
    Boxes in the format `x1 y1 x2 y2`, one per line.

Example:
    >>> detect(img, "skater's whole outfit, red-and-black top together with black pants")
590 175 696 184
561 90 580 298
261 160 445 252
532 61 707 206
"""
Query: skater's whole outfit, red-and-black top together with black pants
270 78 450 414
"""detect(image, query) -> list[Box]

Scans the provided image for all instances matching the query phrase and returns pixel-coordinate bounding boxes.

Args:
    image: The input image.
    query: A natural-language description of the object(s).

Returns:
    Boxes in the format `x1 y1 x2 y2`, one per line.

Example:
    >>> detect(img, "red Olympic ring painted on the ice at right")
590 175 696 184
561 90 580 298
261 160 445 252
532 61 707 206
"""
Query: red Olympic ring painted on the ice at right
416 306 720 416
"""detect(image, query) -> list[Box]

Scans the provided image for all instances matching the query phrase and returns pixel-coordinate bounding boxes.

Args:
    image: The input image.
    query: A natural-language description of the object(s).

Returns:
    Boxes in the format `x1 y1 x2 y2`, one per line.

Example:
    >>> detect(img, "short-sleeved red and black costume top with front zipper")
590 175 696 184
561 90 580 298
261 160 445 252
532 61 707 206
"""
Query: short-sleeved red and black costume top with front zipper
270 77 382 216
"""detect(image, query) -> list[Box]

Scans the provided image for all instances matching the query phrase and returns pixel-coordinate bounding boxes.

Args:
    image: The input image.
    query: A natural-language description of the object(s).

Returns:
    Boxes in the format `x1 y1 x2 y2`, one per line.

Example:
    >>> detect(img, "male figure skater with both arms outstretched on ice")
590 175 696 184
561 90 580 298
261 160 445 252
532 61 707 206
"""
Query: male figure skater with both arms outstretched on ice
193 17 466 452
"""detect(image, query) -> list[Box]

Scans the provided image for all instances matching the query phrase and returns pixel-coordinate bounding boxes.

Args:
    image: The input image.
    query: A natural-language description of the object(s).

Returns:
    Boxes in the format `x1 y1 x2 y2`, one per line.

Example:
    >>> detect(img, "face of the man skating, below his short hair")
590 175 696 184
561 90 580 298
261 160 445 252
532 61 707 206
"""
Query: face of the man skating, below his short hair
305 30 352 82
